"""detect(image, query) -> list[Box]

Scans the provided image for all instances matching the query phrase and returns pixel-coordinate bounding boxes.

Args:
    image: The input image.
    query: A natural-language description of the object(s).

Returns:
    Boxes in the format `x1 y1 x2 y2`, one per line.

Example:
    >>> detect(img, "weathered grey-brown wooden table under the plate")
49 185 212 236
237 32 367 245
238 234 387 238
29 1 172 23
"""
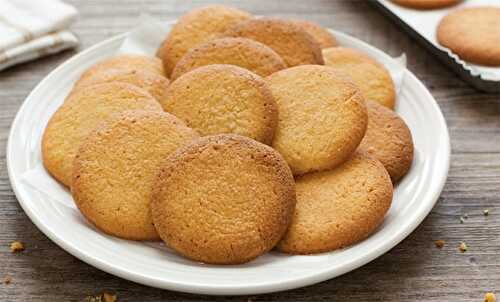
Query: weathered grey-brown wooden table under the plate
0 0 500 302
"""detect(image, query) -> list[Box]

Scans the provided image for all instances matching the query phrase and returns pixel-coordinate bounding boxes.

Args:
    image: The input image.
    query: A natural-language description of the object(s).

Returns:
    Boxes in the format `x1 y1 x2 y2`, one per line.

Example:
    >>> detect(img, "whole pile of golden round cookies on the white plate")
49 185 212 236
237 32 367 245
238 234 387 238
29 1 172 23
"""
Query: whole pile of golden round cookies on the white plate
42 5 413 264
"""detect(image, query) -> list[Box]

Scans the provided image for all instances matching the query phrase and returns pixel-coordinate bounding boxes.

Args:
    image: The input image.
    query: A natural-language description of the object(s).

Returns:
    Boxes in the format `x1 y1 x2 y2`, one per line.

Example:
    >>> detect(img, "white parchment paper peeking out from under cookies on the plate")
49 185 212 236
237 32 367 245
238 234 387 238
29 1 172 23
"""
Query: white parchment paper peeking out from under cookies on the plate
21 15 406 208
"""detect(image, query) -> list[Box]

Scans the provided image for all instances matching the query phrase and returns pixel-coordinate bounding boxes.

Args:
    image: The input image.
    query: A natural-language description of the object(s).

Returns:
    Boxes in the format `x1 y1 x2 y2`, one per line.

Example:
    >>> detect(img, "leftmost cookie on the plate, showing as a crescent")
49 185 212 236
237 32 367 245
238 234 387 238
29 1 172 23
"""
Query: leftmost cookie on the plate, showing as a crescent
42 83 162 186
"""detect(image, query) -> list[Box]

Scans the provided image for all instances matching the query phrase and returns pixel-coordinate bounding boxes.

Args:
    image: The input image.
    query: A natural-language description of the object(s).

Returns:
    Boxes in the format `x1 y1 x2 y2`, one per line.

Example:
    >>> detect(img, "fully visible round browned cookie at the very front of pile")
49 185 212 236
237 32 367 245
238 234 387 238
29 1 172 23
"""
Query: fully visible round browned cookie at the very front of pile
151 134 295 264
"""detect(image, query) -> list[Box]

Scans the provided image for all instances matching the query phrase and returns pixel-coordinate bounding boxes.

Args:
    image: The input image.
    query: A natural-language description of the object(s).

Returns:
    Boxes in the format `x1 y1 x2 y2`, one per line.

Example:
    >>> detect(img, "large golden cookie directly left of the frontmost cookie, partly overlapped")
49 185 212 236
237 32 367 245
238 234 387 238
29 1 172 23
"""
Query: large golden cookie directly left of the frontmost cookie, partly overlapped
71 110 198 240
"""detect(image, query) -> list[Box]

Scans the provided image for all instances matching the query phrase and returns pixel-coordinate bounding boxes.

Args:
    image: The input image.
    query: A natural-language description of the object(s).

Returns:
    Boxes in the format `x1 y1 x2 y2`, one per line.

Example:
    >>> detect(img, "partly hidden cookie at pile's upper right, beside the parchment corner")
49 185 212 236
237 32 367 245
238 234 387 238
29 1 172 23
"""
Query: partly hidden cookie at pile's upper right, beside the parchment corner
323 47 396 109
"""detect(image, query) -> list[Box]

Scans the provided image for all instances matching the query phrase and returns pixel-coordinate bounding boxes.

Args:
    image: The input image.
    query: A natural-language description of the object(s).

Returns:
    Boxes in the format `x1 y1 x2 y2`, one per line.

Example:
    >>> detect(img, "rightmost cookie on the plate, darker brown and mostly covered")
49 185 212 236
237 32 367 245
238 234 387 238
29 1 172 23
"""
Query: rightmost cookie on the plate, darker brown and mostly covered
358 101 413 183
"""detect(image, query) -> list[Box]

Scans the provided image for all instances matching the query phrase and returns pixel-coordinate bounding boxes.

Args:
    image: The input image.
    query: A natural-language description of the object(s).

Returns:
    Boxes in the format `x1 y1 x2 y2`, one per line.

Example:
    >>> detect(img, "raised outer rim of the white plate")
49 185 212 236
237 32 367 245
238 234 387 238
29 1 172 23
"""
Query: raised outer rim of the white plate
6 29 451 295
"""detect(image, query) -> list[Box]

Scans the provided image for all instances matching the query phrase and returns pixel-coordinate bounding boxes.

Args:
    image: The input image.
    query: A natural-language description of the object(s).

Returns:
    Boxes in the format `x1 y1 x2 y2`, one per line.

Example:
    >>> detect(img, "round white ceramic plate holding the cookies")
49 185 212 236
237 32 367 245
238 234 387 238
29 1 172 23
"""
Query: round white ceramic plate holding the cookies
7 25 450 295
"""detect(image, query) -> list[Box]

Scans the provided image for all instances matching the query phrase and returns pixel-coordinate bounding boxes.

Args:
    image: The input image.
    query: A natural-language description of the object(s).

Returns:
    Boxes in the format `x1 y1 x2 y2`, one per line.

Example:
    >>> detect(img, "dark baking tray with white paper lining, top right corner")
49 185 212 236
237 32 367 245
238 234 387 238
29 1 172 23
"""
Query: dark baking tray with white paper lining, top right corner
369 0 500 93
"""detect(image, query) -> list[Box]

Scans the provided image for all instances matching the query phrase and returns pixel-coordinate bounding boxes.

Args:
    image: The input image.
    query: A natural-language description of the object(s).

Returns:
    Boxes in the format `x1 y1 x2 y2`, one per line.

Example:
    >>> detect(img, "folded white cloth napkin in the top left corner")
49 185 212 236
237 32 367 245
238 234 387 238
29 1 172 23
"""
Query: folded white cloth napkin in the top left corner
0 0 78 70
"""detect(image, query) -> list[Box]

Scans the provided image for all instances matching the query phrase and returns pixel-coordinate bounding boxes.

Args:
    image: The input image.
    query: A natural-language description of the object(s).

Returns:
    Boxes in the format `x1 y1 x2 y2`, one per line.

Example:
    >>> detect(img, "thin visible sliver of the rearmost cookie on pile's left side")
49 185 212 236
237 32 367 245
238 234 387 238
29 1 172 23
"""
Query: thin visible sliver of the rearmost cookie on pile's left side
80 54 165 79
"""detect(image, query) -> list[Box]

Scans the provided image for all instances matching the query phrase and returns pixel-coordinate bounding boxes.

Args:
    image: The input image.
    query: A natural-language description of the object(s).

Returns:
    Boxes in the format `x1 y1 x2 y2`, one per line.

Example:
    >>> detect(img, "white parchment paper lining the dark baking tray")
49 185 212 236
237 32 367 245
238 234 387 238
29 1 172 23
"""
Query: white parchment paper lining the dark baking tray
378 0 500 81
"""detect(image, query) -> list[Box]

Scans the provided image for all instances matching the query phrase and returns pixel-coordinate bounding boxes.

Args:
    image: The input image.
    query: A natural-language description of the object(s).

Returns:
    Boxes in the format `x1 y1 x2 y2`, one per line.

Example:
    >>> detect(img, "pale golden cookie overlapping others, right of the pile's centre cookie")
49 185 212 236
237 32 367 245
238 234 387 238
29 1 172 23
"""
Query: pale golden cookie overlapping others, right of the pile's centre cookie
267 65 368 175
